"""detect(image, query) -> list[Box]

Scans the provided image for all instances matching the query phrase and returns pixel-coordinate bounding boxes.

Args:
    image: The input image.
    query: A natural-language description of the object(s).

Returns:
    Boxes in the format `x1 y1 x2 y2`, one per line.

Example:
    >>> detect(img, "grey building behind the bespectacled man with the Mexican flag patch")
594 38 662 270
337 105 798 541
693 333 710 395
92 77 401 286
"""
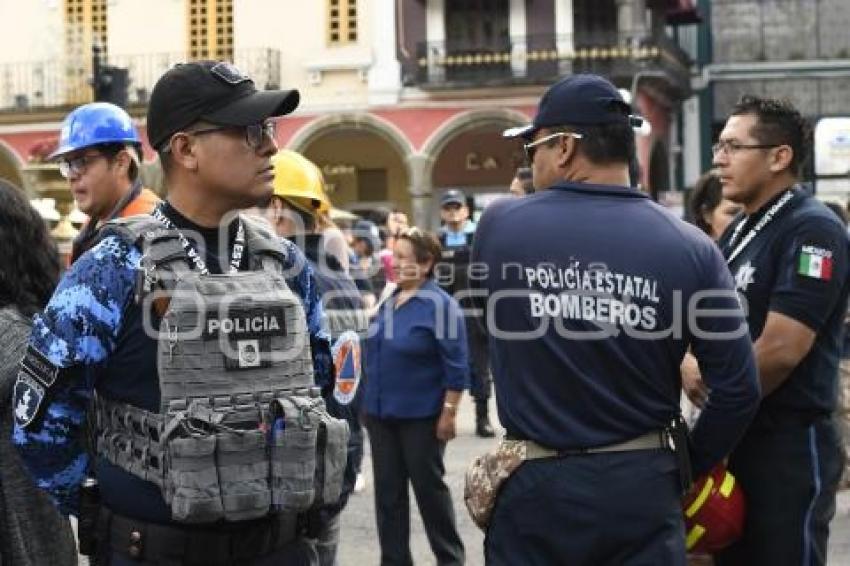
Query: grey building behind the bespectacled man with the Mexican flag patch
683 0 850 201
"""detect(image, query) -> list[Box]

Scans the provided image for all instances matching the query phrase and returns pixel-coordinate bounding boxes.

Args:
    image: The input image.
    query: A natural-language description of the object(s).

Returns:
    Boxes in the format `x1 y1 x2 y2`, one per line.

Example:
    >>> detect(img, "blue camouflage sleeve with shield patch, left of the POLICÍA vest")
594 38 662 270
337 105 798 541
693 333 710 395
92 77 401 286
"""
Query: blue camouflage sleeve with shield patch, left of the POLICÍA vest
12 236 140 514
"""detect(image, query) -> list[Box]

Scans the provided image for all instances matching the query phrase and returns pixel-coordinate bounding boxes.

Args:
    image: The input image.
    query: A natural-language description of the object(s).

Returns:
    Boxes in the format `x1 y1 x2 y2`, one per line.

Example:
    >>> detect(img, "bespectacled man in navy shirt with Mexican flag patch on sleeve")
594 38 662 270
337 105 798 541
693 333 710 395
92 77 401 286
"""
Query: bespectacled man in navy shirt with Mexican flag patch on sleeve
714 97 848 565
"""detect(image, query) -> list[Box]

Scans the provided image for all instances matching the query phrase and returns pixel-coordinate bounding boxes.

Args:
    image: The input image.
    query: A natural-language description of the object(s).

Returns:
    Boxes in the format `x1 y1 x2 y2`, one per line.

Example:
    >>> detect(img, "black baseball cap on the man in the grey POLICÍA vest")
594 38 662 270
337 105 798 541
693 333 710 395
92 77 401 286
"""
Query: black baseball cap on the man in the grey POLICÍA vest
147 61 300 149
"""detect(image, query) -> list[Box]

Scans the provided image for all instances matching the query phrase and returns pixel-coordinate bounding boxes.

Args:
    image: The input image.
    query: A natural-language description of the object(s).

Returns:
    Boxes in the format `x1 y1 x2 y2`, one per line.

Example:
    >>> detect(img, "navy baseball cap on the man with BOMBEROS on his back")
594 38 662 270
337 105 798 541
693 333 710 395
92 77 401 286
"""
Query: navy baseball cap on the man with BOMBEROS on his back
502 74 640 139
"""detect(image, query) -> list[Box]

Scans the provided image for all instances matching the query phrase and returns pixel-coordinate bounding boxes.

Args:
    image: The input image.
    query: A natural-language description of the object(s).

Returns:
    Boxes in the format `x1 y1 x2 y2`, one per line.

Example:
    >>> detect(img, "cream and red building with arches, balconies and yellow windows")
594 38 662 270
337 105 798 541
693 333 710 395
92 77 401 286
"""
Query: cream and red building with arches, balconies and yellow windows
0 0 695 226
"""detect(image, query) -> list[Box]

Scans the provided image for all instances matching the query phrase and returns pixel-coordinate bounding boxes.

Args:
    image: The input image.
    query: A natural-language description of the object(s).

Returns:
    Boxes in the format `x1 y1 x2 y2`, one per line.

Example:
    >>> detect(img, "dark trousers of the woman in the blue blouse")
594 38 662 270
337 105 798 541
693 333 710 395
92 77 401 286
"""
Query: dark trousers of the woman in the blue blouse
366 416 464 566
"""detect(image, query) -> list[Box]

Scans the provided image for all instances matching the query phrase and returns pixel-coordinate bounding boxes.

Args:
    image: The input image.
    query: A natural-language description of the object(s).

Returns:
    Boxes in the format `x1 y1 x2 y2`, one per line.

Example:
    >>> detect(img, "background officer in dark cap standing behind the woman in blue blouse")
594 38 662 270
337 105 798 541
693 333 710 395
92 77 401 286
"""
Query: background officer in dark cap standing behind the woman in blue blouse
435 189 495 438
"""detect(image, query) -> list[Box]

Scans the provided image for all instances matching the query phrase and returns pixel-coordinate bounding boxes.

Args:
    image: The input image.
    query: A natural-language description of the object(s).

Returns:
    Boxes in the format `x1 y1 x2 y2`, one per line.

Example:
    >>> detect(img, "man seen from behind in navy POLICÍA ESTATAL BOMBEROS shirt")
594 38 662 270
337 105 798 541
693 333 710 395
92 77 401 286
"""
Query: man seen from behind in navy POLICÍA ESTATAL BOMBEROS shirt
473 75 759 565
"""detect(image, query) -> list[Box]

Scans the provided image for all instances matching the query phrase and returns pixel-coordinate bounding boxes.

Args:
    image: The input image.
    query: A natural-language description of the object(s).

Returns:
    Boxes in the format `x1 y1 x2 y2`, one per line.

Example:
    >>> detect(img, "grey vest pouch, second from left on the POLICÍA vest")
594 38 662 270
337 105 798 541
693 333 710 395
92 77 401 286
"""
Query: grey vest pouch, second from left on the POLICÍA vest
216 430 271 521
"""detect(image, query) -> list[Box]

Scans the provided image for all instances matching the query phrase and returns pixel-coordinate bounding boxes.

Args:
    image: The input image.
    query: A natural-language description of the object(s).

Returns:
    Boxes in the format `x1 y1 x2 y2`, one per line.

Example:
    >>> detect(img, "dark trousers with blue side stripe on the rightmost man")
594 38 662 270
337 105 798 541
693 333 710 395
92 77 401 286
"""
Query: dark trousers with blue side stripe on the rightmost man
715 419 843 566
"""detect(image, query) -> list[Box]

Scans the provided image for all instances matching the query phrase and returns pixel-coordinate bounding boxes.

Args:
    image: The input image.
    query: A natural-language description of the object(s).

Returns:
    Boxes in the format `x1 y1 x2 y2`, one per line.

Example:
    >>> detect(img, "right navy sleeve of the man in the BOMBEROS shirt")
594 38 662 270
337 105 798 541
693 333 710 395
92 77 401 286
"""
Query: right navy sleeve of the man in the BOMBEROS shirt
689 244 761 476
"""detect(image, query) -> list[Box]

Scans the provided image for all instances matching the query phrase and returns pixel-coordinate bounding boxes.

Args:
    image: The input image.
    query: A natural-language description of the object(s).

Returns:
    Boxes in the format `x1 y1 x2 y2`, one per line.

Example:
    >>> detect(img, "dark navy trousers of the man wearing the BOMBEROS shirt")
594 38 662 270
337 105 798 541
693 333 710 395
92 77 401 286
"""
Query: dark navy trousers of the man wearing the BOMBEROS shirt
484 450 685 566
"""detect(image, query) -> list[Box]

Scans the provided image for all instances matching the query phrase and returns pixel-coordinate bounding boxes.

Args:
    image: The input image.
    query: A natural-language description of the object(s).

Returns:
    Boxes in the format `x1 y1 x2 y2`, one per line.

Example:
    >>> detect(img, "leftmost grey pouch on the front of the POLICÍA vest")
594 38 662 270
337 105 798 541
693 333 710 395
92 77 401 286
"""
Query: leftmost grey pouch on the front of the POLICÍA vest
165 435 224 523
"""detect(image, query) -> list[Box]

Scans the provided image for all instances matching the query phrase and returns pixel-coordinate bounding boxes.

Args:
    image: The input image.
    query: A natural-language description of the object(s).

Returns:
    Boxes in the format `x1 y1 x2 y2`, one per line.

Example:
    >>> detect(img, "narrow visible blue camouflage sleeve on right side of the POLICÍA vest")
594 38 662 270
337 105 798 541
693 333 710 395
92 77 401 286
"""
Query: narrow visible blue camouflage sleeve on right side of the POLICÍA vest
280 238 334 393
